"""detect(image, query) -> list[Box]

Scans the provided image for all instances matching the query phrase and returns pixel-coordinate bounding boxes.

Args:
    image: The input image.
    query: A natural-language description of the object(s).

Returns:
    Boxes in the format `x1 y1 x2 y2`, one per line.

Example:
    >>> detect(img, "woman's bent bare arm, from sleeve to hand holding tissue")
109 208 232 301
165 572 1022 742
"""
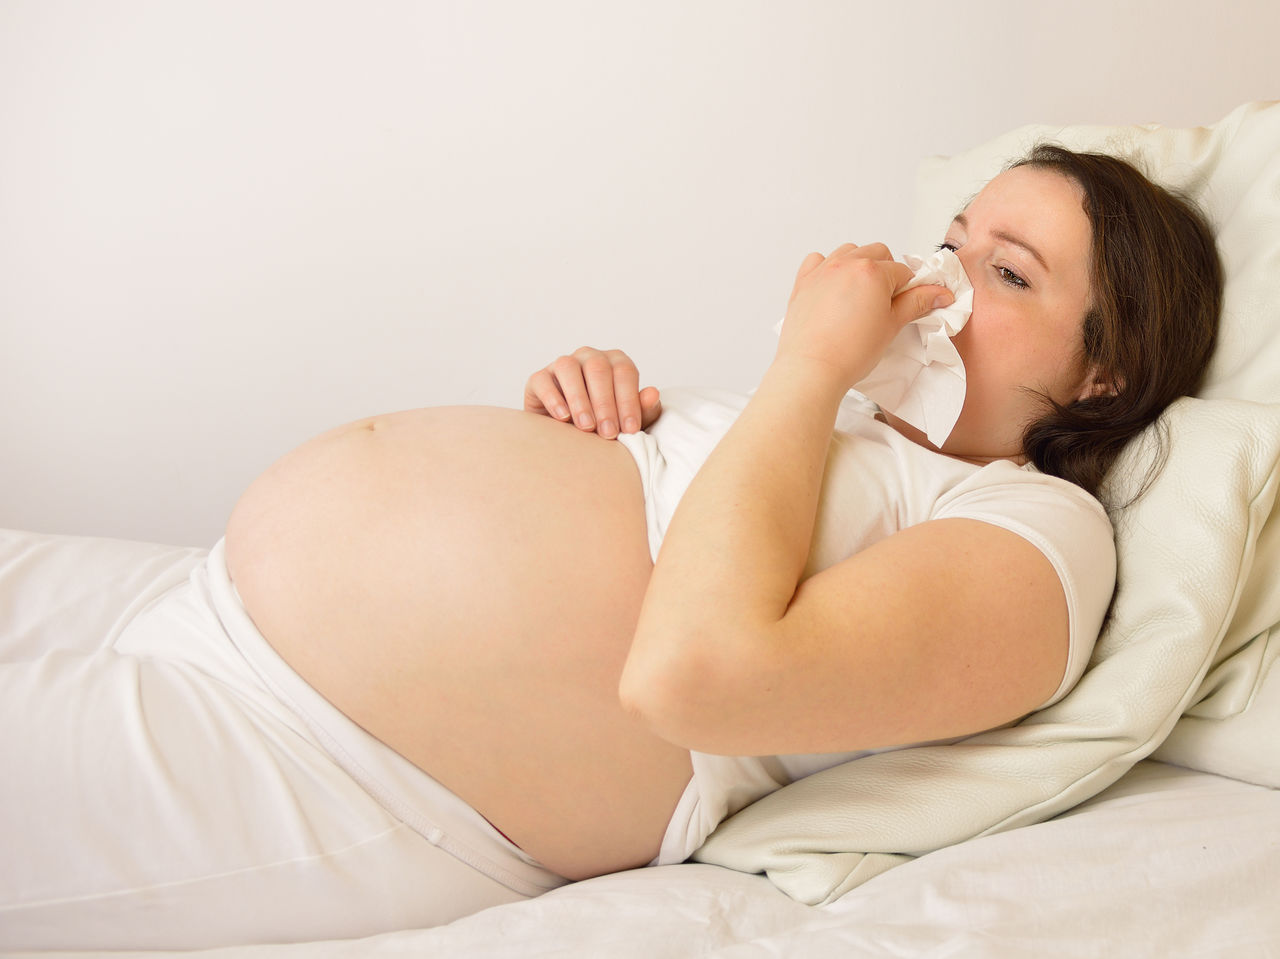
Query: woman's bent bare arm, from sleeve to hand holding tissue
620 247 1068 755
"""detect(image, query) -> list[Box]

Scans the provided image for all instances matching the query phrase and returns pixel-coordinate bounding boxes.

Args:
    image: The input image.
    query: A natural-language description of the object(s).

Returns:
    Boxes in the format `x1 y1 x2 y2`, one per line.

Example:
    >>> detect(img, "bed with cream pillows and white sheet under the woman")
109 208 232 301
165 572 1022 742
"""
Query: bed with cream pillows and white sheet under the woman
0 102 1280 959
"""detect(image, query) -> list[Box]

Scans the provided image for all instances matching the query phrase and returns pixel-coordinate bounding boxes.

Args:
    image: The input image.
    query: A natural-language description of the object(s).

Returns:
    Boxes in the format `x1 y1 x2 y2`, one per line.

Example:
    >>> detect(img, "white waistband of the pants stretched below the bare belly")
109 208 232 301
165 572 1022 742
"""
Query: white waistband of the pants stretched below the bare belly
206 540 568 896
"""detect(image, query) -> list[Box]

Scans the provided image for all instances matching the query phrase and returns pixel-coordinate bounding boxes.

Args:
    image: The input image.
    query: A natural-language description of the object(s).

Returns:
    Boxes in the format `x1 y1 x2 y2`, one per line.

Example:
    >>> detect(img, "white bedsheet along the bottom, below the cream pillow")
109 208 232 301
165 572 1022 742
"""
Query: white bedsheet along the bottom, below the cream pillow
12 762 1280 959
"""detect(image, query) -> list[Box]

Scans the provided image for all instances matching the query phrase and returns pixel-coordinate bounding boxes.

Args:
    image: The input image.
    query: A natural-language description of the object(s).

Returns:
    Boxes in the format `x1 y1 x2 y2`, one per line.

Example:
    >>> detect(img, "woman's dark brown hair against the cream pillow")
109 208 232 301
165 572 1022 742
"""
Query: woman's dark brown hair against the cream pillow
1012 143 1222 504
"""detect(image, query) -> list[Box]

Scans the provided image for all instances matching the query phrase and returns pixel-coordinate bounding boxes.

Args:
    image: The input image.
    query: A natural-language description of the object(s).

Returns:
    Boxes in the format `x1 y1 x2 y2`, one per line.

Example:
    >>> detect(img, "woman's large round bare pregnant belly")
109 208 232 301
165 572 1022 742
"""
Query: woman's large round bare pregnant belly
227 407 690 878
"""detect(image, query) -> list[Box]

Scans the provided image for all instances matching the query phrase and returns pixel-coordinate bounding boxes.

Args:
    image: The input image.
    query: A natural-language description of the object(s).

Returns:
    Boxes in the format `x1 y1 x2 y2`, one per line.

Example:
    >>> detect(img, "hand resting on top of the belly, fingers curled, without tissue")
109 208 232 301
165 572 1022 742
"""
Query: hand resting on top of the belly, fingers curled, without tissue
525 346 662 439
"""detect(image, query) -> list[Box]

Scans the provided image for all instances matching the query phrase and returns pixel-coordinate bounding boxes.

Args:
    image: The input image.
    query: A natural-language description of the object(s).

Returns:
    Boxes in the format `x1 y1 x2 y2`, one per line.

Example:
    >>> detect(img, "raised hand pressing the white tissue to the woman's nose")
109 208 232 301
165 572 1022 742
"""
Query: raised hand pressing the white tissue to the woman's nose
777 243 954 393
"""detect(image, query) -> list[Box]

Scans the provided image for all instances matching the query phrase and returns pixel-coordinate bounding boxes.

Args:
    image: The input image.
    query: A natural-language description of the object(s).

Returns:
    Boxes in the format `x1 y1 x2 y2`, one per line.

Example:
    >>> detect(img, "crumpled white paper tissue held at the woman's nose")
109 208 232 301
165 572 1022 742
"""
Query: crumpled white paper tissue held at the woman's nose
776 250 973 447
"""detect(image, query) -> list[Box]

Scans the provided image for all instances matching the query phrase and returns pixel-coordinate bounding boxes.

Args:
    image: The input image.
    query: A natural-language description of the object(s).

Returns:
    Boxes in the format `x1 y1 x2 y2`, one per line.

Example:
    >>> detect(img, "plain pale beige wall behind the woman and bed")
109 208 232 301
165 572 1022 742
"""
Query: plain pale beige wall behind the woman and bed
0 0 1280 544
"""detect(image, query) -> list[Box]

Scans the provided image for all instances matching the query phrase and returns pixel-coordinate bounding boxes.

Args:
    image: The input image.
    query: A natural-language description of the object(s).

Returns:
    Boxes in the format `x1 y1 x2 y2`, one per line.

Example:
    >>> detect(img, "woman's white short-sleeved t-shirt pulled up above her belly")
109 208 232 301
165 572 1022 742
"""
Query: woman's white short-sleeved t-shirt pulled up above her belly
620 389 1115 866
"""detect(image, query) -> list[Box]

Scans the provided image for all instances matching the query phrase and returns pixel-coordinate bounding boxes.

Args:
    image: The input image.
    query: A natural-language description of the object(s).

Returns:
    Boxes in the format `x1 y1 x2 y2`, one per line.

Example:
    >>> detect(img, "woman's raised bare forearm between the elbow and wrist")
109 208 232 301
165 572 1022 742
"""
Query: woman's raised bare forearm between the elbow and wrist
623 359 846 702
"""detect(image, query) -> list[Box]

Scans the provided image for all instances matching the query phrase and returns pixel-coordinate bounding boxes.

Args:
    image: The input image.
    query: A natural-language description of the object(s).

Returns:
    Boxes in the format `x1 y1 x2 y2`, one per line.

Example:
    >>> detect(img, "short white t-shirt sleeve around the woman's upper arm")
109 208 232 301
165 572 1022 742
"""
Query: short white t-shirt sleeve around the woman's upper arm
933 462 1116 709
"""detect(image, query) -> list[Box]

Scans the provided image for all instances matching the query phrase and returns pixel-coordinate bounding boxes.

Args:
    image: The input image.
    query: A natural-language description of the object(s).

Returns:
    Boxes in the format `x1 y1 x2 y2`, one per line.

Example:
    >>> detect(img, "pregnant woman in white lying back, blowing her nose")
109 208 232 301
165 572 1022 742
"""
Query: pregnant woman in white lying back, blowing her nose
0 147 1221 949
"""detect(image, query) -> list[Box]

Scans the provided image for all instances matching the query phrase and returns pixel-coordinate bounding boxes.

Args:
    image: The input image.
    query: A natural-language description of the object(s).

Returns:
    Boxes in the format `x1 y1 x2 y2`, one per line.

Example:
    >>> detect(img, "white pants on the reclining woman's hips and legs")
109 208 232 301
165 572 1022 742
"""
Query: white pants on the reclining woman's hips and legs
0 543 564 950
